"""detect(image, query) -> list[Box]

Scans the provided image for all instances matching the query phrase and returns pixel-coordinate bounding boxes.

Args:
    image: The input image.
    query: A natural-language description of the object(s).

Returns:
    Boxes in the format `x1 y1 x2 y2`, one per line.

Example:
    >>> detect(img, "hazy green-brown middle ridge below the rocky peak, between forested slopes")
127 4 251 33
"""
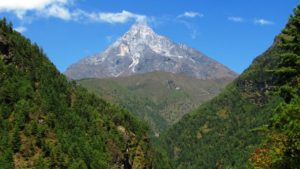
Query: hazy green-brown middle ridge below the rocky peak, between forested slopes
78 72 233 133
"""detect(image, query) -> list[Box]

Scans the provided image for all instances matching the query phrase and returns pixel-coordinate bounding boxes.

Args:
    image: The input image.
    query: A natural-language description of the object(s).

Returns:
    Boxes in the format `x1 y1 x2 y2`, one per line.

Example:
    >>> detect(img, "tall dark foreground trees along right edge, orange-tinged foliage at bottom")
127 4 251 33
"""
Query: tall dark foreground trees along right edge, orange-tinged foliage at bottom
253 6 300 169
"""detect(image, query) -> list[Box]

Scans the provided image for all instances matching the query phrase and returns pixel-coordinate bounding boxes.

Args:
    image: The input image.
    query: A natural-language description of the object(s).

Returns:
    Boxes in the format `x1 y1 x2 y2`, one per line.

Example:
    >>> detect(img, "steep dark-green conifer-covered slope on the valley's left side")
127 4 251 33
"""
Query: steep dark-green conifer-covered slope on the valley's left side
0 19 151 169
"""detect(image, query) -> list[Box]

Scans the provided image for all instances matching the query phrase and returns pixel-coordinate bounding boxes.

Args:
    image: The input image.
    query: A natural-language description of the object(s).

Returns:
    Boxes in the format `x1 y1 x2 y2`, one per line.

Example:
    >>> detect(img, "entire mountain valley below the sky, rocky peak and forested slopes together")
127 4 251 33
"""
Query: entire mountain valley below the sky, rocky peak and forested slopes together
0 3 300 169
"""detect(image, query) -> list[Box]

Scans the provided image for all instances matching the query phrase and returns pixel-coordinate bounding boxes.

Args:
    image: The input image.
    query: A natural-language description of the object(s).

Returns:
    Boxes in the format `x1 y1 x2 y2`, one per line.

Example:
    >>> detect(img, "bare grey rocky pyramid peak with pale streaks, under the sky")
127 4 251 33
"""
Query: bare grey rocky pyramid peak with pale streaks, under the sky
65 24 236 79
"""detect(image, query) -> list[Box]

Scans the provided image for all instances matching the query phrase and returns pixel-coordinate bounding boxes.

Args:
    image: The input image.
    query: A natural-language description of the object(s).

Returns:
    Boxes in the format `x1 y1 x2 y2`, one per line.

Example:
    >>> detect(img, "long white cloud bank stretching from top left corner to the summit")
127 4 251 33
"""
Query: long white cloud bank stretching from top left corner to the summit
0 0 147 24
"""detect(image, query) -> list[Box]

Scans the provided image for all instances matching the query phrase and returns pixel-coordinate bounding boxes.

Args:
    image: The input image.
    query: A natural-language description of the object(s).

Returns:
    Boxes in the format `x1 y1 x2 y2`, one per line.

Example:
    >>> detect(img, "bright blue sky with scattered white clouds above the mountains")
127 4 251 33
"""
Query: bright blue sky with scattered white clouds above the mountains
0 0 300 73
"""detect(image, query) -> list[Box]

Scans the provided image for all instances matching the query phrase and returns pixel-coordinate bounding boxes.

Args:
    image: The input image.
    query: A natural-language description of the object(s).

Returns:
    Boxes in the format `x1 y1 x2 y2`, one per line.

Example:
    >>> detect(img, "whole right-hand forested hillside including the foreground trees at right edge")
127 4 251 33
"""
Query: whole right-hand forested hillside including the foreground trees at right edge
162 7 300 169
